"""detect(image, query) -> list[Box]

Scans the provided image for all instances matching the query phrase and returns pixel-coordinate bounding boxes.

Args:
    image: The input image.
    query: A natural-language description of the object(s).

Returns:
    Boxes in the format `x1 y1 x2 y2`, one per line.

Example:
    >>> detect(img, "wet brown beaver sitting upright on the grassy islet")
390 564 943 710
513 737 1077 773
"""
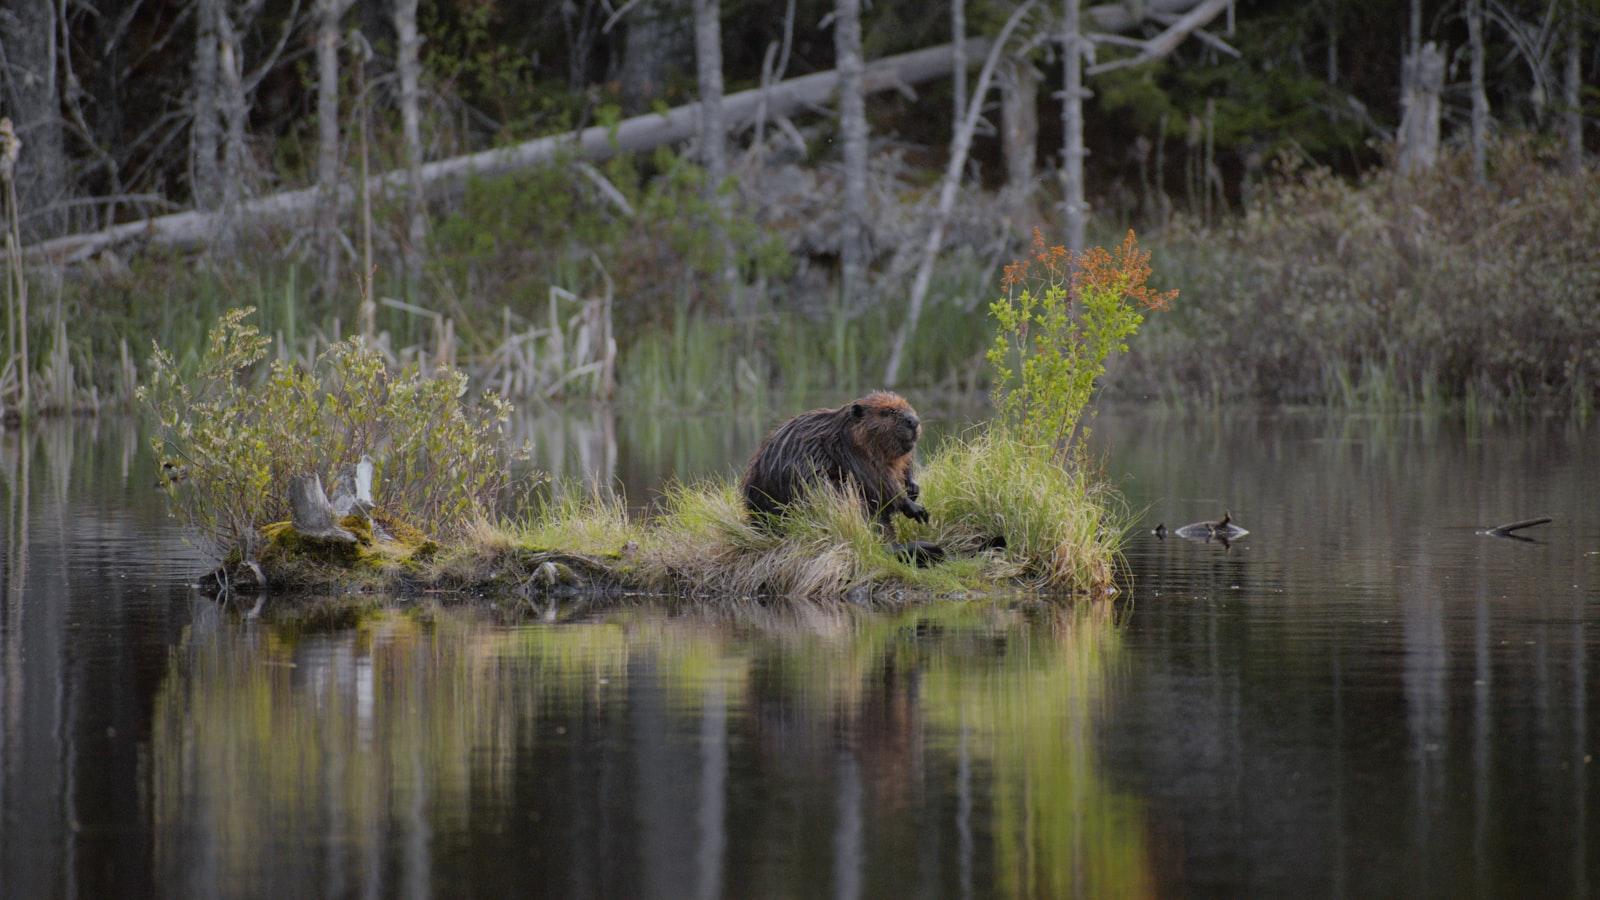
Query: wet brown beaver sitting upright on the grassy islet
739 391 928 527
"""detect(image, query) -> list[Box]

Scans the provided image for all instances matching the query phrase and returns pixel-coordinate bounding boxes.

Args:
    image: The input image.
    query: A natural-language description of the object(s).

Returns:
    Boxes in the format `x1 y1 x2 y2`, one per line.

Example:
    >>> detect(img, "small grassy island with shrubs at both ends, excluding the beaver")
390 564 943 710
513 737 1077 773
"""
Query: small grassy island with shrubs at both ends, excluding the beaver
141 232 1176 602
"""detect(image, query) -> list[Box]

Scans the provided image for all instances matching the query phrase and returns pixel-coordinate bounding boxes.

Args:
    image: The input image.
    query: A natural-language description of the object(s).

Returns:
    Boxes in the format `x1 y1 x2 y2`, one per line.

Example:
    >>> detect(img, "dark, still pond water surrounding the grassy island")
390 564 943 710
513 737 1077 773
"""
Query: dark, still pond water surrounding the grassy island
0 410 1600 897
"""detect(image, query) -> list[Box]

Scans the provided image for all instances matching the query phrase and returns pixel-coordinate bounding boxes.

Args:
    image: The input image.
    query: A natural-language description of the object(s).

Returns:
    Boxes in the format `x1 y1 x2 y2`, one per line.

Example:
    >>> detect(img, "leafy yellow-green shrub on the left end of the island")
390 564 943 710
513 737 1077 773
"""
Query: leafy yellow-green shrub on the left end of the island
139 309 509 557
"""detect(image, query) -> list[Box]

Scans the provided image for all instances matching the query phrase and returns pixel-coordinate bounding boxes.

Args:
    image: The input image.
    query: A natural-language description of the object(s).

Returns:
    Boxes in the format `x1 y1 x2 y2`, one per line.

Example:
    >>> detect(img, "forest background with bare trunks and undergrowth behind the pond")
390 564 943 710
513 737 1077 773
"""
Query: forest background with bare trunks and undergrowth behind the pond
0 0 1600 416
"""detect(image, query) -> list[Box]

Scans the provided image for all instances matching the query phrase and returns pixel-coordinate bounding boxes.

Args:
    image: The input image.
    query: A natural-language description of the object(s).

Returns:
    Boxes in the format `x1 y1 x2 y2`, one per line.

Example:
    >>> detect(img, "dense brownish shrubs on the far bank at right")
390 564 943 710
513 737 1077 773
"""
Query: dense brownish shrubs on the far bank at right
1118 144 1600 408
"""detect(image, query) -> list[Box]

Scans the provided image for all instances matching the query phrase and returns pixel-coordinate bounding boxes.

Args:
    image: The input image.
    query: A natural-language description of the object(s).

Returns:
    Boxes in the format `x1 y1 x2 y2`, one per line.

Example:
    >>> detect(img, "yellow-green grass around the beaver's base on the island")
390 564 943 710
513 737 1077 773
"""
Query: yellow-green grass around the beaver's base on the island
453 434 1123 601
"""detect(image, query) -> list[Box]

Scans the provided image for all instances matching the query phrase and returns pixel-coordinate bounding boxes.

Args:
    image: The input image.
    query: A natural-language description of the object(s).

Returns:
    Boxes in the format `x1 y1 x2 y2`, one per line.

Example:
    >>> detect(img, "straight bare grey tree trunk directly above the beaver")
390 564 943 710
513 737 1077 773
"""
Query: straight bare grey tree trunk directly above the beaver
834 0 867 309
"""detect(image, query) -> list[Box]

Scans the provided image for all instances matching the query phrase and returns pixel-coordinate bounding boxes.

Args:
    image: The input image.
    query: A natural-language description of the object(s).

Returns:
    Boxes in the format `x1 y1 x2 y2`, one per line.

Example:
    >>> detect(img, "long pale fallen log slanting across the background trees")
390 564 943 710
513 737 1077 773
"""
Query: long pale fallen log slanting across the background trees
24 38 989 263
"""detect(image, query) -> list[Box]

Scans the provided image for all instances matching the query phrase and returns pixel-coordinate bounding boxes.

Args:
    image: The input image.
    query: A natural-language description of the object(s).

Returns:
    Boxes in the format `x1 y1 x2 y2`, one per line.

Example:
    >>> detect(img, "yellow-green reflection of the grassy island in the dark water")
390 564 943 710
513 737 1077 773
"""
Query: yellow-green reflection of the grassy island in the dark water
150 605 1150 897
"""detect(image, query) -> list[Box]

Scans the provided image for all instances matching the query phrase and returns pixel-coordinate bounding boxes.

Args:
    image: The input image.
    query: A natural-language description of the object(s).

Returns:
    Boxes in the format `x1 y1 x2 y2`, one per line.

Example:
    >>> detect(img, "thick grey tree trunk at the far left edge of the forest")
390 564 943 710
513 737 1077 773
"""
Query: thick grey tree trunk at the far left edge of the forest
0 0 67 239
